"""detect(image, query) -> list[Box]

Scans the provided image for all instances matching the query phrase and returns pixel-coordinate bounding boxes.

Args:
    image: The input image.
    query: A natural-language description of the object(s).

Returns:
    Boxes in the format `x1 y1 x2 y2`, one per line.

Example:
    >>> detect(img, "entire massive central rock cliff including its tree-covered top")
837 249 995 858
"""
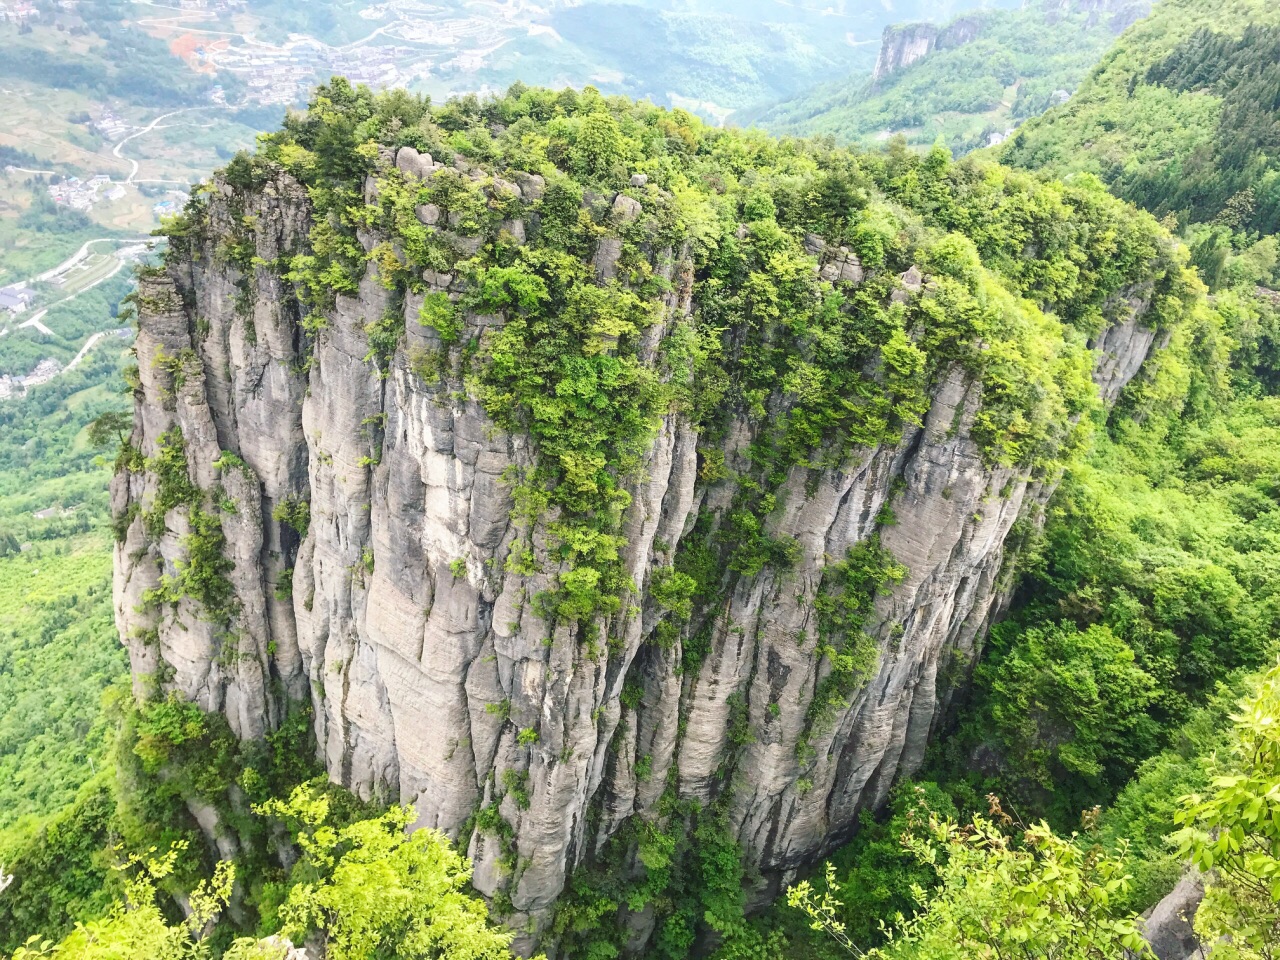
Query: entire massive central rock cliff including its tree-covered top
113 88 1198 947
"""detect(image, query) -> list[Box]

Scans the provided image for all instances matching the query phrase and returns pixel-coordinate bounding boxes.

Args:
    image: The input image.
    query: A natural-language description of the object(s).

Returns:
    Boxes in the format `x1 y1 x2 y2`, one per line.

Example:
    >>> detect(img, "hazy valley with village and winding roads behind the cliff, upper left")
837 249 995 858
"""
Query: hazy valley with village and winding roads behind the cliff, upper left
0 0 880 401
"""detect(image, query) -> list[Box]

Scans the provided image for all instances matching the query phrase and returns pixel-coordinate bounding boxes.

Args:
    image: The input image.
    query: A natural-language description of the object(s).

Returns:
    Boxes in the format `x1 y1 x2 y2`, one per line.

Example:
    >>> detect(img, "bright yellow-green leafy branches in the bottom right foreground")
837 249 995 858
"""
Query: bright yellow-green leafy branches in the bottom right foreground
787 667 1280 960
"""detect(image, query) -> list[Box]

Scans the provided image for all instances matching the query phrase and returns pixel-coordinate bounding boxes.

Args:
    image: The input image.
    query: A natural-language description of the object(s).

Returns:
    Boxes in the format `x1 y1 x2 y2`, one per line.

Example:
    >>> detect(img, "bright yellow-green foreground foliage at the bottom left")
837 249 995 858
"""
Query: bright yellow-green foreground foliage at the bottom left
3 787 524 960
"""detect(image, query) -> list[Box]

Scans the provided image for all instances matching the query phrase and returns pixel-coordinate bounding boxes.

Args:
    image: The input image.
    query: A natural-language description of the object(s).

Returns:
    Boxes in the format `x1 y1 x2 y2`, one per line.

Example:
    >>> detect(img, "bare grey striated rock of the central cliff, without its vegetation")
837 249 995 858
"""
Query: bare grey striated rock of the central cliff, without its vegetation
113 151 1172 946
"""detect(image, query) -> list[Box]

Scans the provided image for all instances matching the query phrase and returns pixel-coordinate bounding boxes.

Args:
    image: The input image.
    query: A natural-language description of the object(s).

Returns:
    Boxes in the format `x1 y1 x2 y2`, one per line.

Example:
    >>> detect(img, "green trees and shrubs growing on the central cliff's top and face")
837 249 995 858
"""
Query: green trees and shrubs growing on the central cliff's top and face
74 81 1216 960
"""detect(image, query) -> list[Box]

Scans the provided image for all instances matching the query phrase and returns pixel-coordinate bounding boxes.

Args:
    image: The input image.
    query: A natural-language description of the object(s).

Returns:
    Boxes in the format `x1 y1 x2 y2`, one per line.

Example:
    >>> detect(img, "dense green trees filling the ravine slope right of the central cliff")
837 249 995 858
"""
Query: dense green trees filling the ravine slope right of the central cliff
747 245 1280 957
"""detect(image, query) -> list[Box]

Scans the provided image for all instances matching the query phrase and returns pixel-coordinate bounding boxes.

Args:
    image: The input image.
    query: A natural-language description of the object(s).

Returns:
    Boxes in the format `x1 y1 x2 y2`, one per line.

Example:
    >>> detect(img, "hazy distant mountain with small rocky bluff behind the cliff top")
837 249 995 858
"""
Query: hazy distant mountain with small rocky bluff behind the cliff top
732 0 1151 154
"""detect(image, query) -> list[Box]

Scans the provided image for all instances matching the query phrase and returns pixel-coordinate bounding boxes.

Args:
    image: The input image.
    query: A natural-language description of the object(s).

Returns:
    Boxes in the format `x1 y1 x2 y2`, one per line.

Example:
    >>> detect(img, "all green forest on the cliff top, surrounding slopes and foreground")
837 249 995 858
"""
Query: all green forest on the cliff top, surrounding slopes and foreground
0 0 1280 960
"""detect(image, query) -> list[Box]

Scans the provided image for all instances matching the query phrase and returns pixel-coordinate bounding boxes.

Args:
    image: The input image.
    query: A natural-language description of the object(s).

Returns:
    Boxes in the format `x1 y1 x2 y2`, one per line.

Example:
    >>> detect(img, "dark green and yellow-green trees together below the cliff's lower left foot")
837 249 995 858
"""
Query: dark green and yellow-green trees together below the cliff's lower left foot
0 695 524 960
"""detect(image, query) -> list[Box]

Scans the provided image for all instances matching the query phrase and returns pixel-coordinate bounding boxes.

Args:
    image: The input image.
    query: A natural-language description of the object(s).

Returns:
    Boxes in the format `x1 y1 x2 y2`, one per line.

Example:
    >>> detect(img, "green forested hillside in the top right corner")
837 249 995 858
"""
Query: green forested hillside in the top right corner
1004 0 1280 233
